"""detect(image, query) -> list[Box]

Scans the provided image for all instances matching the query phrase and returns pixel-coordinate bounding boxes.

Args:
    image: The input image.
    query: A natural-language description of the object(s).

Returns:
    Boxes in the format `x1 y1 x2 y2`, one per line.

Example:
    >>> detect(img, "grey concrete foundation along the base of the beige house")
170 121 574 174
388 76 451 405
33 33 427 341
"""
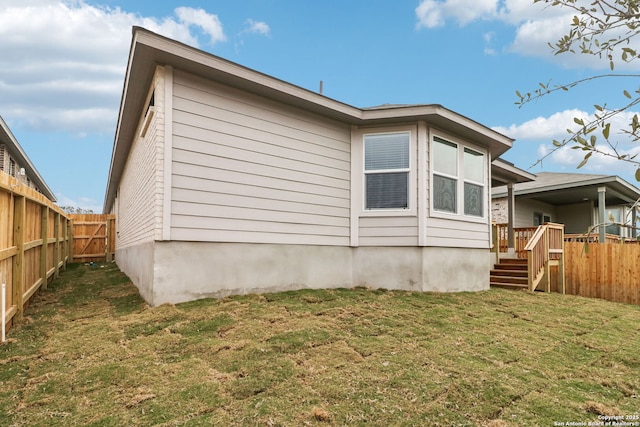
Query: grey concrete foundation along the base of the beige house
116 242 489 306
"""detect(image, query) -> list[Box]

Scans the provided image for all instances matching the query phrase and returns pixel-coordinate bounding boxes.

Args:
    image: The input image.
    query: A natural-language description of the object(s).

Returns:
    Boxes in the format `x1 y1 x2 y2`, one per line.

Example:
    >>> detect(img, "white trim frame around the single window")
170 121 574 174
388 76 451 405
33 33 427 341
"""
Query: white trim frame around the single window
358 125 418 217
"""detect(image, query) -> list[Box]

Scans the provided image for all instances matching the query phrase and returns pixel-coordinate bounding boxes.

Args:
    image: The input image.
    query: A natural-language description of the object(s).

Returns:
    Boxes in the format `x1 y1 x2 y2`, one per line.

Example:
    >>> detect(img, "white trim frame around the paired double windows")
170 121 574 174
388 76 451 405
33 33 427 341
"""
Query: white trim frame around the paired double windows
429 131 489 224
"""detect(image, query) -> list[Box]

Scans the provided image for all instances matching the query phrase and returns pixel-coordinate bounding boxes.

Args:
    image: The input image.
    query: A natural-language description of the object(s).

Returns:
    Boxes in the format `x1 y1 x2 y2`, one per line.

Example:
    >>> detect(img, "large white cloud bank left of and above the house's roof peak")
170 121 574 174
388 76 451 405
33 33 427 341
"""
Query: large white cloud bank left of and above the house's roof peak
0 0 226 134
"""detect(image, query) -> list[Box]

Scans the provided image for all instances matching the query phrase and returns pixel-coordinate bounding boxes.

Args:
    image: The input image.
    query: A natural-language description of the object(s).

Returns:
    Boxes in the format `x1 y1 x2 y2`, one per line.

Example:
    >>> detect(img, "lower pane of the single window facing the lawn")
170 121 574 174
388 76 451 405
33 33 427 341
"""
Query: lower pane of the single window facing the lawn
366 172 409 209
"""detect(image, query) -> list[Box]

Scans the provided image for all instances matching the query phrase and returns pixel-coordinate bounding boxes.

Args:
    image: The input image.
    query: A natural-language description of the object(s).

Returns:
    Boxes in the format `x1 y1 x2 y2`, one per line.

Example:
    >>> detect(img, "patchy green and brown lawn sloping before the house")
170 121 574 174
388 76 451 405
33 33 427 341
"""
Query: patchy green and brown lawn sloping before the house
0 264 640 426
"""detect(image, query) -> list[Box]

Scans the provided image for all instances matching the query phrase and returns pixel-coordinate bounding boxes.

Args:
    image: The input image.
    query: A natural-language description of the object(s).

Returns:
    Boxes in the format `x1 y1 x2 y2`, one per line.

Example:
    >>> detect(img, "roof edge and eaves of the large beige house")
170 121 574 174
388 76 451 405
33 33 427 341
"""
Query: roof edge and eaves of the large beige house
104 27 513 210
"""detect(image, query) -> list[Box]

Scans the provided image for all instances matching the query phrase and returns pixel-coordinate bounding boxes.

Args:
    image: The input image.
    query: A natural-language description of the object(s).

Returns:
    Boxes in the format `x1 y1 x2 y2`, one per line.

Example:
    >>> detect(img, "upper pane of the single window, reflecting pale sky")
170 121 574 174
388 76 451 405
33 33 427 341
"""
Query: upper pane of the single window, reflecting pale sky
364 133 409 170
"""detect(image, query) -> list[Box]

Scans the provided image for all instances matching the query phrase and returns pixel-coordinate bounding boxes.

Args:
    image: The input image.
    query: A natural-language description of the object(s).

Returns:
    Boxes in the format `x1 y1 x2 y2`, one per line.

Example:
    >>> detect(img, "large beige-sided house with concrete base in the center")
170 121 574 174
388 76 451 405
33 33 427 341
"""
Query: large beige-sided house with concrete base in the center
104 28 528 305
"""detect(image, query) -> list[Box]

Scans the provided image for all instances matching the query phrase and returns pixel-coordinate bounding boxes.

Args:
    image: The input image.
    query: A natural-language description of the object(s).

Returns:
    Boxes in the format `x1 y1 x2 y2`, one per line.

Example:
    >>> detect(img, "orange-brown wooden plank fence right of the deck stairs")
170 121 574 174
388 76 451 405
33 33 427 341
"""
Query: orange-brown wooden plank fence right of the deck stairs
564 242 640 304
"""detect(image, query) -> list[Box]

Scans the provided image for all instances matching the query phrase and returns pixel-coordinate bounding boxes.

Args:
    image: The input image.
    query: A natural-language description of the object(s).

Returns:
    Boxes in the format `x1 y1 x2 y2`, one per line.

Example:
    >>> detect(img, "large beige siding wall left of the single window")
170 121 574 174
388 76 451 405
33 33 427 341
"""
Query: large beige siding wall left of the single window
171 72 350 245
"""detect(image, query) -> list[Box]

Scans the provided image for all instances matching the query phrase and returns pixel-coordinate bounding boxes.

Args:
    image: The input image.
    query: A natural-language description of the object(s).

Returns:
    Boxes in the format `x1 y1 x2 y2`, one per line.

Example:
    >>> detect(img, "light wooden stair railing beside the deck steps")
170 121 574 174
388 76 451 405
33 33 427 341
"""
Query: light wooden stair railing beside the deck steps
524 223 564 293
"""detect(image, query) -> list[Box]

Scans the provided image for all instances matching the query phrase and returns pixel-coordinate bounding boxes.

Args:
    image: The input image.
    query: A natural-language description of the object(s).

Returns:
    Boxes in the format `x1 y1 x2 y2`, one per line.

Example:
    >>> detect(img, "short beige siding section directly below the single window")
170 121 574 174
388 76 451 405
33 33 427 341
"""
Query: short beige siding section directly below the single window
360 216 418 246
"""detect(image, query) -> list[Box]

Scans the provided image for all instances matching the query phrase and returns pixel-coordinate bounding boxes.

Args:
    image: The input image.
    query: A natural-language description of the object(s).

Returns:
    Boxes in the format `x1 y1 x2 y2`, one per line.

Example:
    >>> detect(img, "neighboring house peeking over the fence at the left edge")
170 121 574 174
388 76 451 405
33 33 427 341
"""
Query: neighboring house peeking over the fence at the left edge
0 117 56 202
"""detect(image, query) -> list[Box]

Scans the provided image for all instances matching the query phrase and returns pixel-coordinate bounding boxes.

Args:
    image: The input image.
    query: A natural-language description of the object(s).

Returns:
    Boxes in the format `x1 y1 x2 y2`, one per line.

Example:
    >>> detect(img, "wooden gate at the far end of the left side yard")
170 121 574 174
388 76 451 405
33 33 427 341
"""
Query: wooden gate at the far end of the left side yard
69 214 116 262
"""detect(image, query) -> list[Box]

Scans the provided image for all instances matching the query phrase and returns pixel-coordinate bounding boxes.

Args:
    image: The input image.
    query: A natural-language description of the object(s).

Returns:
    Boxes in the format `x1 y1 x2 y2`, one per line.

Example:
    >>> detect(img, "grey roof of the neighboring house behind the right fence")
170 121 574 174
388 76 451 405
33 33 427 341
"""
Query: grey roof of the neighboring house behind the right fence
491 172 640 205
